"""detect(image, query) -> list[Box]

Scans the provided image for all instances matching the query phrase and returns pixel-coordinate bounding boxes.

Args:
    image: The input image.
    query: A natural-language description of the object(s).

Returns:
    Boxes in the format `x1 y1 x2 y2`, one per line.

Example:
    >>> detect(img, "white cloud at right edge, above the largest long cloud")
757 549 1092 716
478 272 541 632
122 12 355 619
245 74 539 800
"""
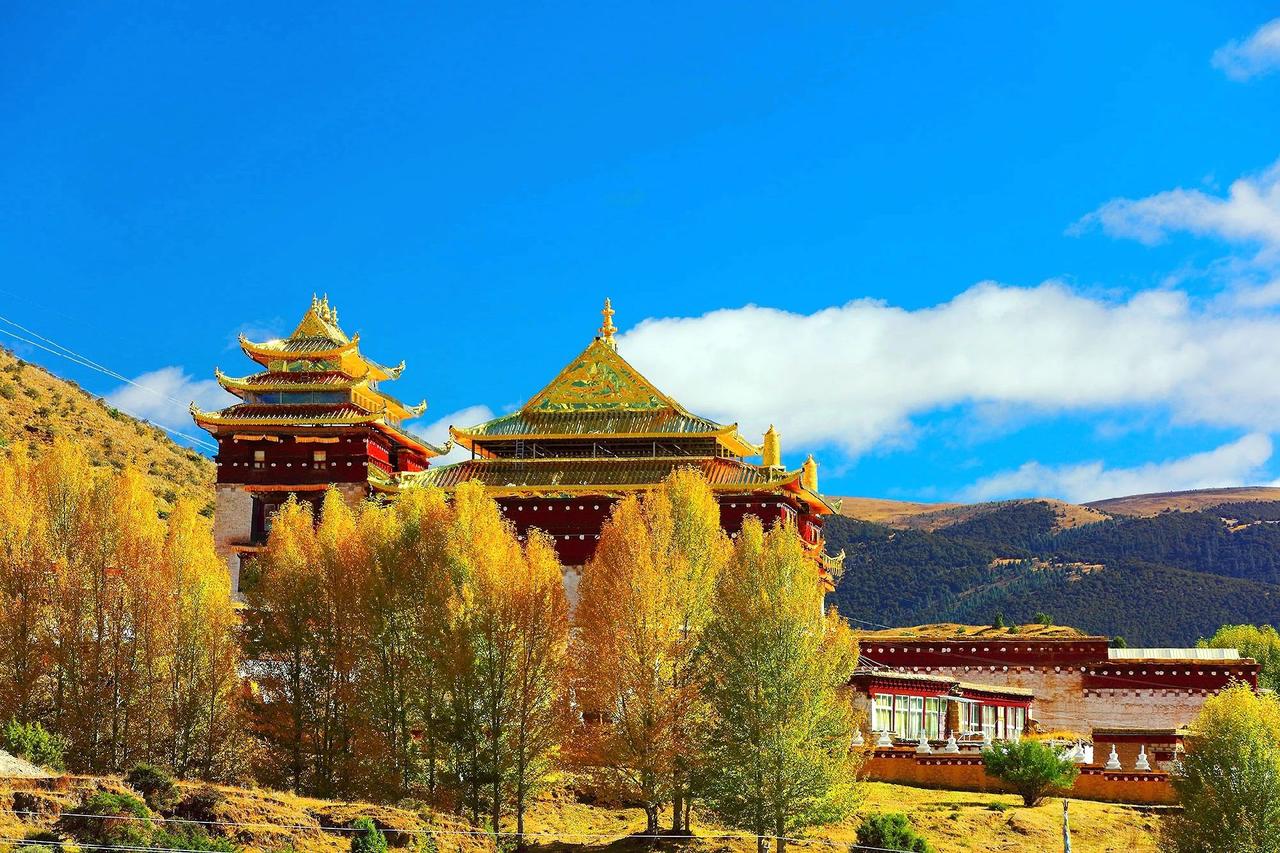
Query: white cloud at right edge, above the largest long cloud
1071 161 1280 250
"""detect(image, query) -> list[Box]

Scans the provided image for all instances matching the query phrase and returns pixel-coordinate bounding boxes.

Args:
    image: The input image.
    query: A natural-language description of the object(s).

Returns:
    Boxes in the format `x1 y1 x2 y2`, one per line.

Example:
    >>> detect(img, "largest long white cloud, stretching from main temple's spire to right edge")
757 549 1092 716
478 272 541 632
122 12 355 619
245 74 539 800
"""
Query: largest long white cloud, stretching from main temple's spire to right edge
620 282 1280 462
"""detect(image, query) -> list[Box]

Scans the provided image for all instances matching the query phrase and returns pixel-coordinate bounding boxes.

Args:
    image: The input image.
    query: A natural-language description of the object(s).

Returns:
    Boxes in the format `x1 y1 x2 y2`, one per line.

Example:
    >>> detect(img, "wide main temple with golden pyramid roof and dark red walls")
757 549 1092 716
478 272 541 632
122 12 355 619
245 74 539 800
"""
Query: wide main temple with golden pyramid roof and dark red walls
401 300 842 594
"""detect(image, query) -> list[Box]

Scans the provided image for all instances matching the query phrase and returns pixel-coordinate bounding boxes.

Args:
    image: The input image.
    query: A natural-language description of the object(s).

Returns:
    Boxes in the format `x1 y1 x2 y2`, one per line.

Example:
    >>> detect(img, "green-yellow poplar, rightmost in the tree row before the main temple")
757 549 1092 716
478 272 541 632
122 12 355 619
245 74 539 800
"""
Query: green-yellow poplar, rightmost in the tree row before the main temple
703 516 858 853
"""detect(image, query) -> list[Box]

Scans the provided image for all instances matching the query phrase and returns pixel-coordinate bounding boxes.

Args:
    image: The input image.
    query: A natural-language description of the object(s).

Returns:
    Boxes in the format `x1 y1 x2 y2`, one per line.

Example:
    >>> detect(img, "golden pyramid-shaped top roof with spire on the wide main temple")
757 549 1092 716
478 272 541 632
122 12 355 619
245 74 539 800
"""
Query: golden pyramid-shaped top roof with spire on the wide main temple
449 318 760 456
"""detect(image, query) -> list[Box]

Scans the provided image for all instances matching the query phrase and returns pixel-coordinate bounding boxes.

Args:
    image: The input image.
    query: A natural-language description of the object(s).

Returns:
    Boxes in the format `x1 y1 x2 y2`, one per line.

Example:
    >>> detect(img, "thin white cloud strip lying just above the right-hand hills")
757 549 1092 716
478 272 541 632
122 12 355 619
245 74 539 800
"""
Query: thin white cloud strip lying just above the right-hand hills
963 433 1271 502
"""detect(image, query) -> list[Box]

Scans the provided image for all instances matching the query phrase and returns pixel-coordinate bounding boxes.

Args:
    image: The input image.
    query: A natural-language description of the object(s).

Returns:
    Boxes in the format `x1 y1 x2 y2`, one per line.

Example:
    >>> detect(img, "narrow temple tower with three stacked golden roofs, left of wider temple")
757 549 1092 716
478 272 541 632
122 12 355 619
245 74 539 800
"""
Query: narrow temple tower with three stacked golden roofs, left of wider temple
191 297 444 592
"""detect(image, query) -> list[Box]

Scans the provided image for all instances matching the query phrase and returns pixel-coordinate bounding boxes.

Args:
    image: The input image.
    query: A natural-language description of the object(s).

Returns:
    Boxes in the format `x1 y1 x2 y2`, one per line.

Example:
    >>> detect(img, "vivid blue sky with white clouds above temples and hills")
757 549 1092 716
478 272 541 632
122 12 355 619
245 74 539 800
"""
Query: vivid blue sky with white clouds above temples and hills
0 3 1280 500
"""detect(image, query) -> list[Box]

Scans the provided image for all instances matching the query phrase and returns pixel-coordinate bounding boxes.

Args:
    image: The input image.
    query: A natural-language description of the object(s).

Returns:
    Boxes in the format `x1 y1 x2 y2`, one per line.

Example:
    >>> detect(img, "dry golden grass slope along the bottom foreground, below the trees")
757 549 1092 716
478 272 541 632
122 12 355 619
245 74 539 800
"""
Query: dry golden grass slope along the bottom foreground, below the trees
0 777 1158 853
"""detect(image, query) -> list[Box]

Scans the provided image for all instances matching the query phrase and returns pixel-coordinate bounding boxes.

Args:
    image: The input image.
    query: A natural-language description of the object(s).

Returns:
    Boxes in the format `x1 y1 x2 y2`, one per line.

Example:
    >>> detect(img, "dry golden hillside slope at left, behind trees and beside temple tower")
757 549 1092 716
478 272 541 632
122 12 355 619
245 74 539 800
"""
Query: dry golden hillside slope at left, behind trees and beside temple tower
0 348 214 515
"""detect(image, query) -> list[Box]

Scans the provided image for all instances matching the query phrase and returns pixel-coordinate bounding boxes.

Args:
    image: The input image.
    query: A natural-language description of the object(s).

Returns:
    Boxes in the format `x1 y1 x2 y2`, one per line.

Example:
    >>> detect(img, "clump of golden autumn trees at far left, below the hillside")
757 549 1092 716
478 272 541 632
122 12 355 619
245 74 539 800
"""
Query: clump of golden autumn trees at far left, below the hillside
0 439 238 775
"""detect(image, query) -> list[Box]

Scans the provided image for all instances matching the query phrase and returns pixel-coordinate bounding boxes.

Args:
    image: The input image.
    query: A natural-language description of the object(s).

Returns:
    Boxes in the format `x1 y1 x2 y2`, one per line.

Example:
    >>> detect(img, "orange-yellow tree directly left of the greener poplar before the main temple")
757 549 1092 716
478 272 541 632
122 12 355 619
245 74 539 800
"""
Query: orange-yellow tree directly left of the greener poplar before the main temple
573 470 728 831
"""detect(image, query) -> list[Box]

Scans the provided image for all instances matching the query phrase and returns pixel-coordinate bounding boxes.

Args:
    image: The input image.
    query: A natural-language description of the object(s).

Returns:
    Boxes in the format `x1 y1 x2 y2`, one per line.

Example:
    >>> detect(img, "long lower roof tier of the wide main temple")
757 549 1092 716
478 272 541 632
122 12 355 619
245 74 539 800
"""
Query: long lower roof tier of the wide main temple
403 456 833 514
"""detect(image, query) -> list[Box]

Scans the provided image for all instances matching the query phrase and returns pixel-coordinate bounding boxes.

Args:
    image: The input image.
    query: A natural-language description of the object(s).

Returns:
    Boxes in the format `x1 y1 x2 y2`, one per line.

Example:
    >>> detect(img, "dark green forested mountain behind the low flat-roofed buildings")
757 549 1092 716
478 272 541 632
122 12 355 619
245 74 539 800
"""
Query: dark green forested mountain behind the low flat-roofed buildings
827 494 1280 646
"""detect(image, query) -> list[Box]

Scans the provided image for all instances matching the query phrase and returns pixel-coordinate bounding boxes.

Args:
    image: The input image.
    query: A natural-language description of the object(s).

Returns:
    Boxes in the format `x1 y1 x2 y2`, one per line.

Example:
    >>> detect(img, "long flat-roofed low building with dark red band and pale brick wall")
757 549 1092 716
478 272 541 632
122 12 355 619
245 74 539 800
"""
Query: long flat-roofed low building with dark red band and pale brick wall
860 625 1260 735
